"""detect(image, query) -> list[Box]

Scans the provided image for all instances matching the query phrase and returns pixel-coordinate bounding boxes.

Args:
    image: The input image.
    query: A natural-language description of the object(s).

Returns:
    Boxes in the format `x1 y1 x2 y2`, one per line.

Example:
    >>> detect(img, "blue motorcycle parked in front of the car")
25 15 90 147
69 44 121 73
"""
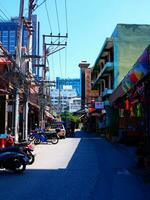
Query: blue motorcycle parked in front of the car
29 129 59 145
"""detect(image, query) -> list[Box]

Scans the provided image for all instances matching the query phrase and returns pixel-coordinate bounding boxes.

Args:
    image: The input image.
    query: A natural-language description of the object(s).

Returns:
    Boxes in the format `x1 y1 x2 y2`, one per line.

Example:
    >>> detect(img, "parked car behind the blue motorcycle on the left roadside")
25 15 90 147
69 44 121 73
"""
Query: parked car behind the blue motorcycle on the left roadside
45 124 66 138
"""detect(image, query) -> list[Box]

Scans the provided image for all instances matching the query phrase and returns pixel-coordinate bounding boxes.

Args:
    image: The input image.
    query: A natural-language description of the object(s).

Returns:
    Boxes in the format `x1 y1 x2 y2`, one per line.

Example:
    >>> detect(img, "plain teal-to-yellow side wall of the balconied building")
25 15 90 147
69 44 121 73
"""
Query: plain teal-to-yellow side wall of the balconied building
112 24 150 84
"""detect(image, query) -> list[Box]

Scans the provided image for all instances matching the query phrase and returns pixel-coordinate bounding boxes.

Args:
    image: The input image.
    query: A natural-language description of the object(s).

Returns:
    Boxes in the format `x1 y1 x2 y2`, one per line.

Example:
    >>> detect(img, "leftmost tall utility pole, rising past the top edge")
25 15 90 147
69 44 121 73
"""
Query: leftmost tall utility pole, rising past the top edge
13 0 24 143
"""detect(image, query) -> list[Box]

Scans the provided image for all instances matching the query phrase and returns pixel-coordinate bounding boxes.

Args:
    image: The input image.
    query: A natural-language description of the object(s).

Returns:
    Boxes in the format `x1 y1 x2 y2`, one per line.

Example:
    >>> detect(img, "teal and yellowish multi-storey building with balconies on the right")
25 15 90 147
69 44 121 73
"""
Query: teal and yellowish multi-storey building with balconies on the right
91 24 150 101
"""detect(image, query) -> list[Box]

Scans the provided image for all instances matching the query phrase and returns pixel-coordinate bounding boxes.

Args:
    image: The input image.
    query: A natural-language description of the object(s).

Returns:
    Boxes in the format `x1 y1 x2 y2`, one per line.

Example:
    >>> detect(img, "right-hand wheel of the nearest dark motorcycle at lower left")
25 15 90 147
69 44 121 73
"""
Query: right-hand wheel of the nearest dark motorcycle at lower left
12 158 26 173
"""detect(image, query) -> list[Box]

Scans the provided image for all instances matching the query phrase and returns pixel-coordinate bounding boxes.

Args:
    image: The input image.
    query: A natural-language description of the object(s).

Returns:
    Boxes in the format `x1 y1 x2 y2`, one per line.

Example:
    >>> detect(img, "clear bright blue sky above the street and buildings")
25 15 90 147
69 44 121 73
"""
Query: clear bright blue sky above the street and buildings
0 0 150 80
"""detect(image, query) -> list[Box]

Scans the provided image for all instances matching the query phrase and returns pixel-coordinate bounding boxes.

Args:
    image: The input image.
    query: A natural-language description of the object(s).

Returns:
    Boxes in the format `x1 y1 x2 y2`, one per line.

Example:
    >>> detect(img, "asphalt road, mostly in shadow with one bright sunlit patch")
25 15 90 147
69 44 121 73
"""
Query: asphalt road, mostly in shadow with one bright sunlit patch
0 132 150 200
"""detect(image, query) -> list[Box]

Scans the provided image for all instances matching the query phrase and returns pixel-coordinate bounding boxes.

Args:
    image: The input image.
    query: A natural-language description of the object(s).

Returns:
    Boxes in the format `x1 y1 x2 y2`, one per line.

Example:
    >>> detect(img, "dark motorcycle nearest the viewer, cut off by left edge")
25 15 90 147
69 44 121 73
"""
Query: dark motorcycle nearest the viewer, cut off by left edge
0 147 29 173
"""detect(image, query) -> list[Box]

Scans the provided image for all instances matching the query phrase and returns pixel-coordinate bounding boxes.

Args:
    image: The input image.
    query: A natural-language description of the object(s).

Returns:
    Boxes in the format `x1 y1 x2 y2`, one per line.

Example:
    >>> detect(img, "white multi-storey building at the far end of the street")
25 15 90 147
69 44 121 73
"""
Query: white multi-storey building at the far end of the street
50 85 77 113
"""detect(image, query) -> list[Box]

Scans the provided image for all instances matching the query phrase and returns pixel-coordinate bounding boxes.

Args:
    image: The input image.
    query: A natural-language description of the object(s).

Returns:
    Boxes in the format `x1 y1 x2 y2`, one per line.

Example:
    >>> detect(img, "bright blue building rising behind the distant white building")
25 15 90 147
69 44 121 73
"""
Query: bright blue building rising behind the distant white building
56 77 81 97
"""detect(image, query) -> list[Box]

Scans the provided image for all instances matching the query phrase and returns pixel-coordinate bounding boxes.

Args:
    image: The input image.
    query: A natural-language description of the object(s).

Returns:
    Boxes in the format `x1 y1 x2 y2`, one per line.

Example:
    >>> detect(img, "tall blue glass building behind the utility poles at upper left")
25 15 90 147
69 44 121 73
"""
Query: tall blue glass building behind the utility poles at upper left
0 15 39 75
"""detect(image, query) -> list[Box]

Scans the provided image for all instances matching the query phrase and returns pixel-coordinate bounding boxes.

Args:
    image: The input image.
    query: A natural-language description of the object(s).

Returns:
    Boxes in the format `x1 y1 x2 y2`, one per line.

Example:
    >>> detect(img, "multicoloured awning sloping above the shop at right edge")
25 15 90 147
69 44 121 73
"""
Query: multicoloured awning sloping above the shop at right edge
109 45 150 102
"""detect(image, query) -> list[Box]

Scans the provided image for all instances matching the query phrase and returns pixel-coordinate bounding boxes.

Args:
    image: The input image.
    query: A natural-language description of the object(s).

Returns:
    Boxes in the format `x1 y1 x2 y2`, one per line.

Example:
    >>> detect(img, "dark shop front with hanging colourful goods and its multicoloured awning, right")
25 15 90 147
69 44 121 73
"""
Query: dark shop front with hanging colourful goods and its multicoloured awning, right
110 46 150 145
